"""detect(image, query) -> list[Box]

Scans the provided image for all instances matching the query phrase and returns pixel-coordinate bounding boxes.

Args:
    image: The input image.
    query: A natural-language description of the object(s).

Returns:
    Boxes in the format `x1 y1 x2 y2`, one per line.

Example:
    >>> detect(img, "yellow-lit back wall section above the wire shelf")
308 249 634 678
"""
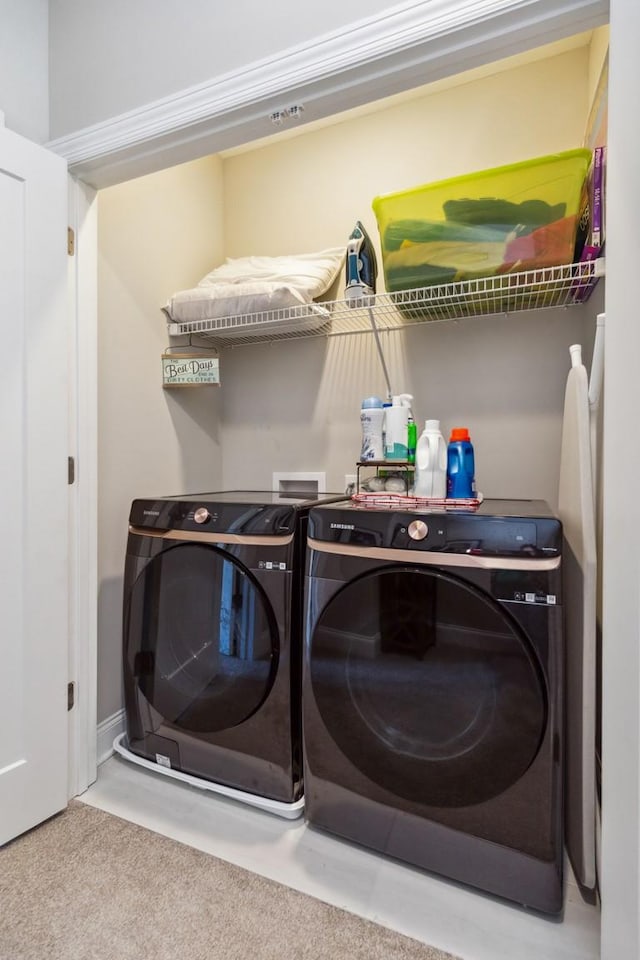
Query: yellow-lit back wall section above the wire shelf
224 46 589 256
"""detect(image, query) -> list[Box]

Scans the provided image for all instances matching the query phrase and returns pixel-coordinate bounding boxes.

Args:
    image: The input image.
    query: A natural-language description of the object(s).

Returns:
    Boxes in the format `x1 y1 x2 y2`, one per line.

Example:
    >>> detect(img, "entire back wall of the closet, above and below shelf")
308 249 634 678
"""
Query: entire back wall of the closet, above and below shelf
221 46 593 503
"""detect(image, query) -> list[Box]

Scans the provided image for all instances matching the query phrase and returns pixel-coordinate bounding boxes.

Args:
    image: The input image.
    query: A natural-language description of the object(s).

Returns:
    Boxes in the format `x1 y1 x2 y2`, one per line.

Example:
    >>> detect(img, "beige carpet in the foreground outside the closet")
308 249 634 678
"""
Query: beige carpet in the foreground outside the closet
0 801 460 960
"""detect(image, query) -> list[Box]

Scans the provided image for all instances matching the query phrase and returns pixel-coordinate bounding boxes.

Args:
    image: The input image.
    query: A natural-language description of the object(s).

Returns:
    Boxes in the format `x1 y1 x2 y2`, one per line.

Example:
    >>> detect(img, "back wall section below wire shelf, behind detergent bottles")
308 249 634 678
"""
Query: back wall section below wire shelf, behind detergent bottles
221 304 602 505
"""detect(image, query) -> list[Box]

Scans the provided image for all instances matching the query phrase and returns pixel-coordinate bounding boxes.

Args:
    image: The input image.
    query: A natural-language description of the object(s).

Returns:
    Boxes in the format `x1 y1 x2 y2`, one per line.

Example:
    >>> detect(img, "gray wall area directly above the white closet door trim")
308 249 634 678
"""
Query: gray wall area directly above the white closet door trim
50 0 400 139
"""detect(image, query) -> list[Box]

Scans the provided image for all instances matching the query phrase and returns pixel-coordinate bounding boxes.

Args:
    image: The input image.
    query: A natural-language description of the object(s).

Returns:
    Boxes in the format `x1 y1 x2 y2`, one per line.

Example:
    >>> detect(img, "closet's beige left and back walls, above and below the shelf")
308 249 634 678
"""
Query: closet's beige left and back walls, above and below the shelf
98 41 602 720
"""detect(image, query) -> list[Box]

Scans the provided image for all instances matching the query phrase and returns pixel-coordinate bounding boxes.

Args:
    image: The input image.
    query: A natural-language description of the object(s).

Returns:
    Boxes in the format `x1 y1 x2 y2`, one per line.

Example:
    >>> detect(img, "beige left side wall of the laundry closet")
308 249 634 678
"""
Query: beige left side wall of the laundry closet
98 157 223 720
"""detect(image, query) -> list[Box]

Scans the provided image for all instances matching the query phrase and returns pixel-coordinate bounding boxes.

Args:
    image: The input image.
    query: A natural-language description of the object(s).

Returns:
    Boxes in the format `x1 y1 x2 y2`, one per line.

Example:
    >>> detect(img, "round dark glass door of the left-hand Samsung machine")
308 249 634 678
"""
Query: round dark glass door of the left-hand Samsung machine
125 543 278 732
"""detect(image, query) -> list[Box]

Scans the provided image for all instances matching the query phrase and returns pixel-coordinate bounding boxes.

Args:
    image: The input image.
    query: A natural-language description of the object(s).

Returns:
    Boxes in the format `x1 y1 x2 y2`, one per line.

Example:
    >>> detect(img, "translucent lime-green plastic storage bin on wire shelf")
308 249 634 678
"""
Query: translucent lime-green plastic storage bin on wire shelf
373 149 591 292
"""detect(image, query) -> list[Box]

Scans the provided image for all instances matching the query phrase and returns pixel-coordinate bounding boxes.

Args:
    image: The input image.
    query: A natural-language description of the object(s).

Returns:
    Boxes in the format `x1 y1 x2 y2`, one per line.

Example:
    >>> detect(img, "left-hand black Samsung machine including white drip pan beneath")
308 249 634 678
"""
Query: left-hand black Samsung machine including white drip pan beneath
114 491 338 817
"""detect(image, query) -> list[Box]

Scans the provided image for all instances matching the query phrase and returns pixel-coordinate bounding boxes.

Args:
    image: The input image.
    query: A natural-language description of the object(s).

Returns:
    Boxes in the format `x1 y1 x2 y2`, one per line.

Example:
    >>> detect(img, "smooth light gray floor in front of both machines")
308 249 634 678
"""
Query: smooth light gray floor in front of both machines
79 756 600 960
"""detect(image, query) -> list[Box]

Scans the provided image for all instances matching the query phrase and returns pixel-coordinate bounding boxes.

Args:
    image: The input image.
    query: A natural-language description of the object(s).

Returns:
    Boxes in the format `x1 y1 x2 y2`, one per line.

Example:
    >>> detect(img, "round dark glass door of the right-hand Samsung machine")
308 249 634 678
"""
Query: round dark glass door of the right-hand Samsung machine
309 567 548 807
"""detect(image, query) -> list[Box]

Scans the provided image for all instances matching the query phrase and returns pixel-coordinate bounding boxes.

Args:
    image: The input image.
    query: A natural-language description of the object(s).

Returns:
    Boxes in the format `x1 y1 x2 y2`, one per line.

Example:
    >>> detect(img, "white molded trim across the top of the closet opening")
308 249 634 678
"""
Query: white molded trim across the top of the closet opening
47 0 608 187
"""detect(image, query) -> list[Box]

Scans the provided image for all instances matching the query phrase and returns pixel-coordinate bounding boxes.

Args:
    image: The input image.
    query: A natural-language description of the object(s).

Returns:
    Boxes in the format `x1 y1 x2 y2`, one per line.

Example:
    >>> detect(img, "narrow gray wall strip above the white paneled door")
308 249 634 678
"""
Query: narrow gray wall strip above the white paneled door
0 0 49 143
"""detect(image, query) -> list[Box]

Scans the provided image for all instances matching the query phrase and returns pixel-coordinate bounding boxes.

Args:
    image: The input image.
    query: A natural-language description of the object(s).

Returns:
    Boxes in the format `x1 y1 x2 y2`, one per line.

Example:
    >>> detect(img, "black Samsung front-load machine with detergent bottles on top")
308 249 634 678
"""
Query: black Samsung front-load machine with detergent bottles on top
302 500 563 914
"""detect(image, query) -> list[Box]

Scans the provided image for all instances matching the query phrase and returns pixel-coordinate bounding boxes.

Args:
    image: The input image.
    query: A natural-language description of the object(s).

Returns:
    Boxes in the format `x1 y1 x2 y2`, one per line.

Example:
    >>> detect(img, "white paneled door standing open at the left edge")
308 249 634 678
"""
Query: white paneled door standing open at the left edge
0 115 69 843
